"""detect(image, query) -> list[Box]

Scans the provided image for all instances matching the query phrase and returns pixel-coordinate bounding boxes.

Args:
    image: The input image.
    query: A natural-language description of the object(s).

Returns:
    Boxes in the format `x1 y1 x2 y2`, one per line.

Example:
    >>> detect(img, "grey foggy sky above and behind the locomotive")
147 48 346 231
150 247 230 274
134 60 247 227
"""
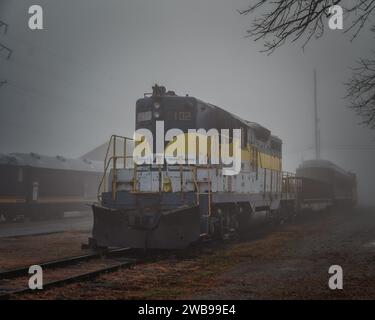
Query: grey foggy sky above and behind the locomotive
0 0 375 204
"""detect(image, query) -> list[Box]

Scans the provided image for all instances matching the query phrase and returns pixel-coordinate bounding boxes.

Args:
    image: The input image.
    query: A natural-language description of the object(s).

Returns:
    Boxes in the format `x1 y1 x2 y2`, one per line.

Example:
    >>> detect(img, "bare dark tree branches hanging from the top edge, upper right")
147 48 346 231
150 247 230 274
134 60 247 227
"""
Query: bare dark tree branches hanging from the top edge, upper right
239 0 375 54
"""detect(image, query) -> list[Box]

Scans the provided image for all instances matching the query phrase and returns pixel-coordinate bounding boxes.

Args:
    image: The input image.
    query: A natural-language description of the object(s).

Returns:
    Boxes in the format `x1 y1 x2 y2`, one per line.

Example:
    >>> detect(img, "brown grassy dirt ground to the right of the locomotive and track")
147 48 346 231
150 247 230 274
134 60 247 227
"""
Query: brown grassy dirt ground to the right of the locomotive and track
11 208 375 300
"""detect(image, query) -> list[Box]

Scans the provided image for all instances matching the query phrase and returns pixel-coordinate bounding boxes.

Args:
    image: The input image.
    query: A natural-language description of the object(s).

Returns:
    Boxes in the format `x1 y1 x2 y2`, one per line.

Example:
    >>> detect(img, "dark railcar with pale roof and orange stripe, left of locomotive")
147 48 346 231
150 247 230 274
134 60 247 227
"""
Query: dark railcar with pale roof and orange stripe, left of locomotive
0 153 103 221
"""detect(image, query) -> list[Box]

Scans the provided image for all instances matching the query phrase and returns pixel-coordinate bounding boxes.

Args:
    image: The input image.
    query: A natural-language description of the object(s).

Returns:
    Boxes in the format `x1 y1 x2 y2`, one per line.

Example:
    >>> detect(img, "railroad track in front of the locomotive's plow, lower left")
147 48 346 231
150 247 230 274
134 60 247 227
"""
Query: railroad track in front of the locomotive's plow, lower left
0 248 137 300
